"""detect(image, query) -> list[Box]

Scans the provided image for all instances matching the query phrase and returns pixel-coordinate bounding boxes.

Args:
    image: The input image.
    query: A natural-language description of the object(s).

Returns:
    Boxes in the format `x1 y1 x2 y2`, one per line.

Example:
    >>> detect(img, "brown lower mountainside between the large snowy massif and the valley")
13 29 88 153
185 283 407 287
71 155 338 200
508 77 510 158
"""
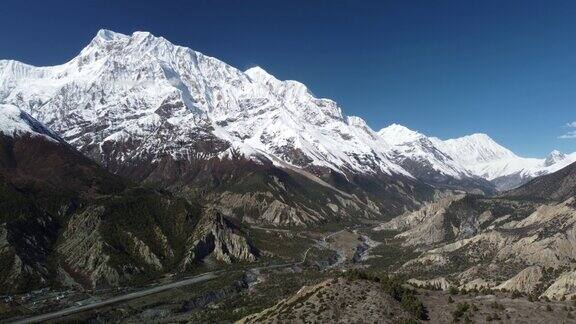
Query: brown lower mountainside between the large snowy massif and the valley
95 147 436 226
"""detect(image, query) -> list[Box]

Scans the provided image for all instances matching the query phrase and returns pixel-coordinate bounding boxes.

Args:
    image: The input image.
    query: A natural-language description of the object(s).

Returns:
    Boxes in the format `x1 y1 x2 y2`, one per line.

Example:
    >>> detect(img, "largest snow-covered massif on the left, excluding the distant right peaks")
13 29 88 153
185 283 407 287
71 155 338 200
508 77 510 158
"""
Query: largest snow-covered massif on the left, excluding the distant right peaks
0 30 408 174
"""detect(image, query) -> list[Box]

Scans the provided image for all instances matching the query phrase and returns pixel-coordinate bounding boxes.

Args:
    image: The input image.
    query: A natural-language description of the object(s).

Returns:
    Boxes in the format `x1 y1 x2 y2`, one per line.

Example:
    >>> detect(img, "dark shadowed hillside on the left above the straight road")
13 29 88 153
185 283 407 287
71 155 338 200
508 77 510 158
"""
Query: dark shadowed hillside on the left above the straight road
0 134 257 292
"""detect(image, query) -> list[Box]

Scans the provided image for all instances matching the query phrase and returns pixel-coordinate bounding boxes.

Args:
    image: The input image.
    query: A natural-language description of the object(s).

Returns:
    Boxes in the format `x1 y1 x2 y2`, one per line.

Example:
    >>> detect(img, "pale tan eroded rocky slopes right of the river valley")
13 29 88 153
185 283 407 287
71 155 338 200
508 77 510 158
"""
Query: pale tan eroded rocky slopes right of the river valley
377 161 576 299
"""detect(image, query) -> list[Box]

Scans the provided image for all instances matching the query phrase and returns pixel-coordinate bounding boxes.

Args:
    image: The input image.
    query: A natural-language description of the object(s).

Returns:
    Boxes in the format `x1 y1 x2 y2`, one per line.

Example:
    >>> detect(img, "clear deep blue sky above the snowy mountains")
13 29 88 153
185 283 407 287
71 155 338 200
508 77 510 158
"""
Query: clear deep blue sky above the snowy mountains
0 0 576 156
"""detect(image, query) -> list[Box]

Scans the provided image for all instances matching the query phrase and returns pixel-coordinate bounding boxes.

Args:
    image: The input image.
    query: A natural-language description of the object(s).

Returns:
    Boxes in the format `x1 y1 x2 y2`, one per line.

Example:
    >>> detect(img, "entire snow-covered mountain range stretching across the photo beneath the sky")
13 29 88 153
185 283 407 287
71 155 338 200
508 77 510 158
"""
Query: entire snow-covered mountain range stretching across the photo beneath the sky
0 30 576 191
